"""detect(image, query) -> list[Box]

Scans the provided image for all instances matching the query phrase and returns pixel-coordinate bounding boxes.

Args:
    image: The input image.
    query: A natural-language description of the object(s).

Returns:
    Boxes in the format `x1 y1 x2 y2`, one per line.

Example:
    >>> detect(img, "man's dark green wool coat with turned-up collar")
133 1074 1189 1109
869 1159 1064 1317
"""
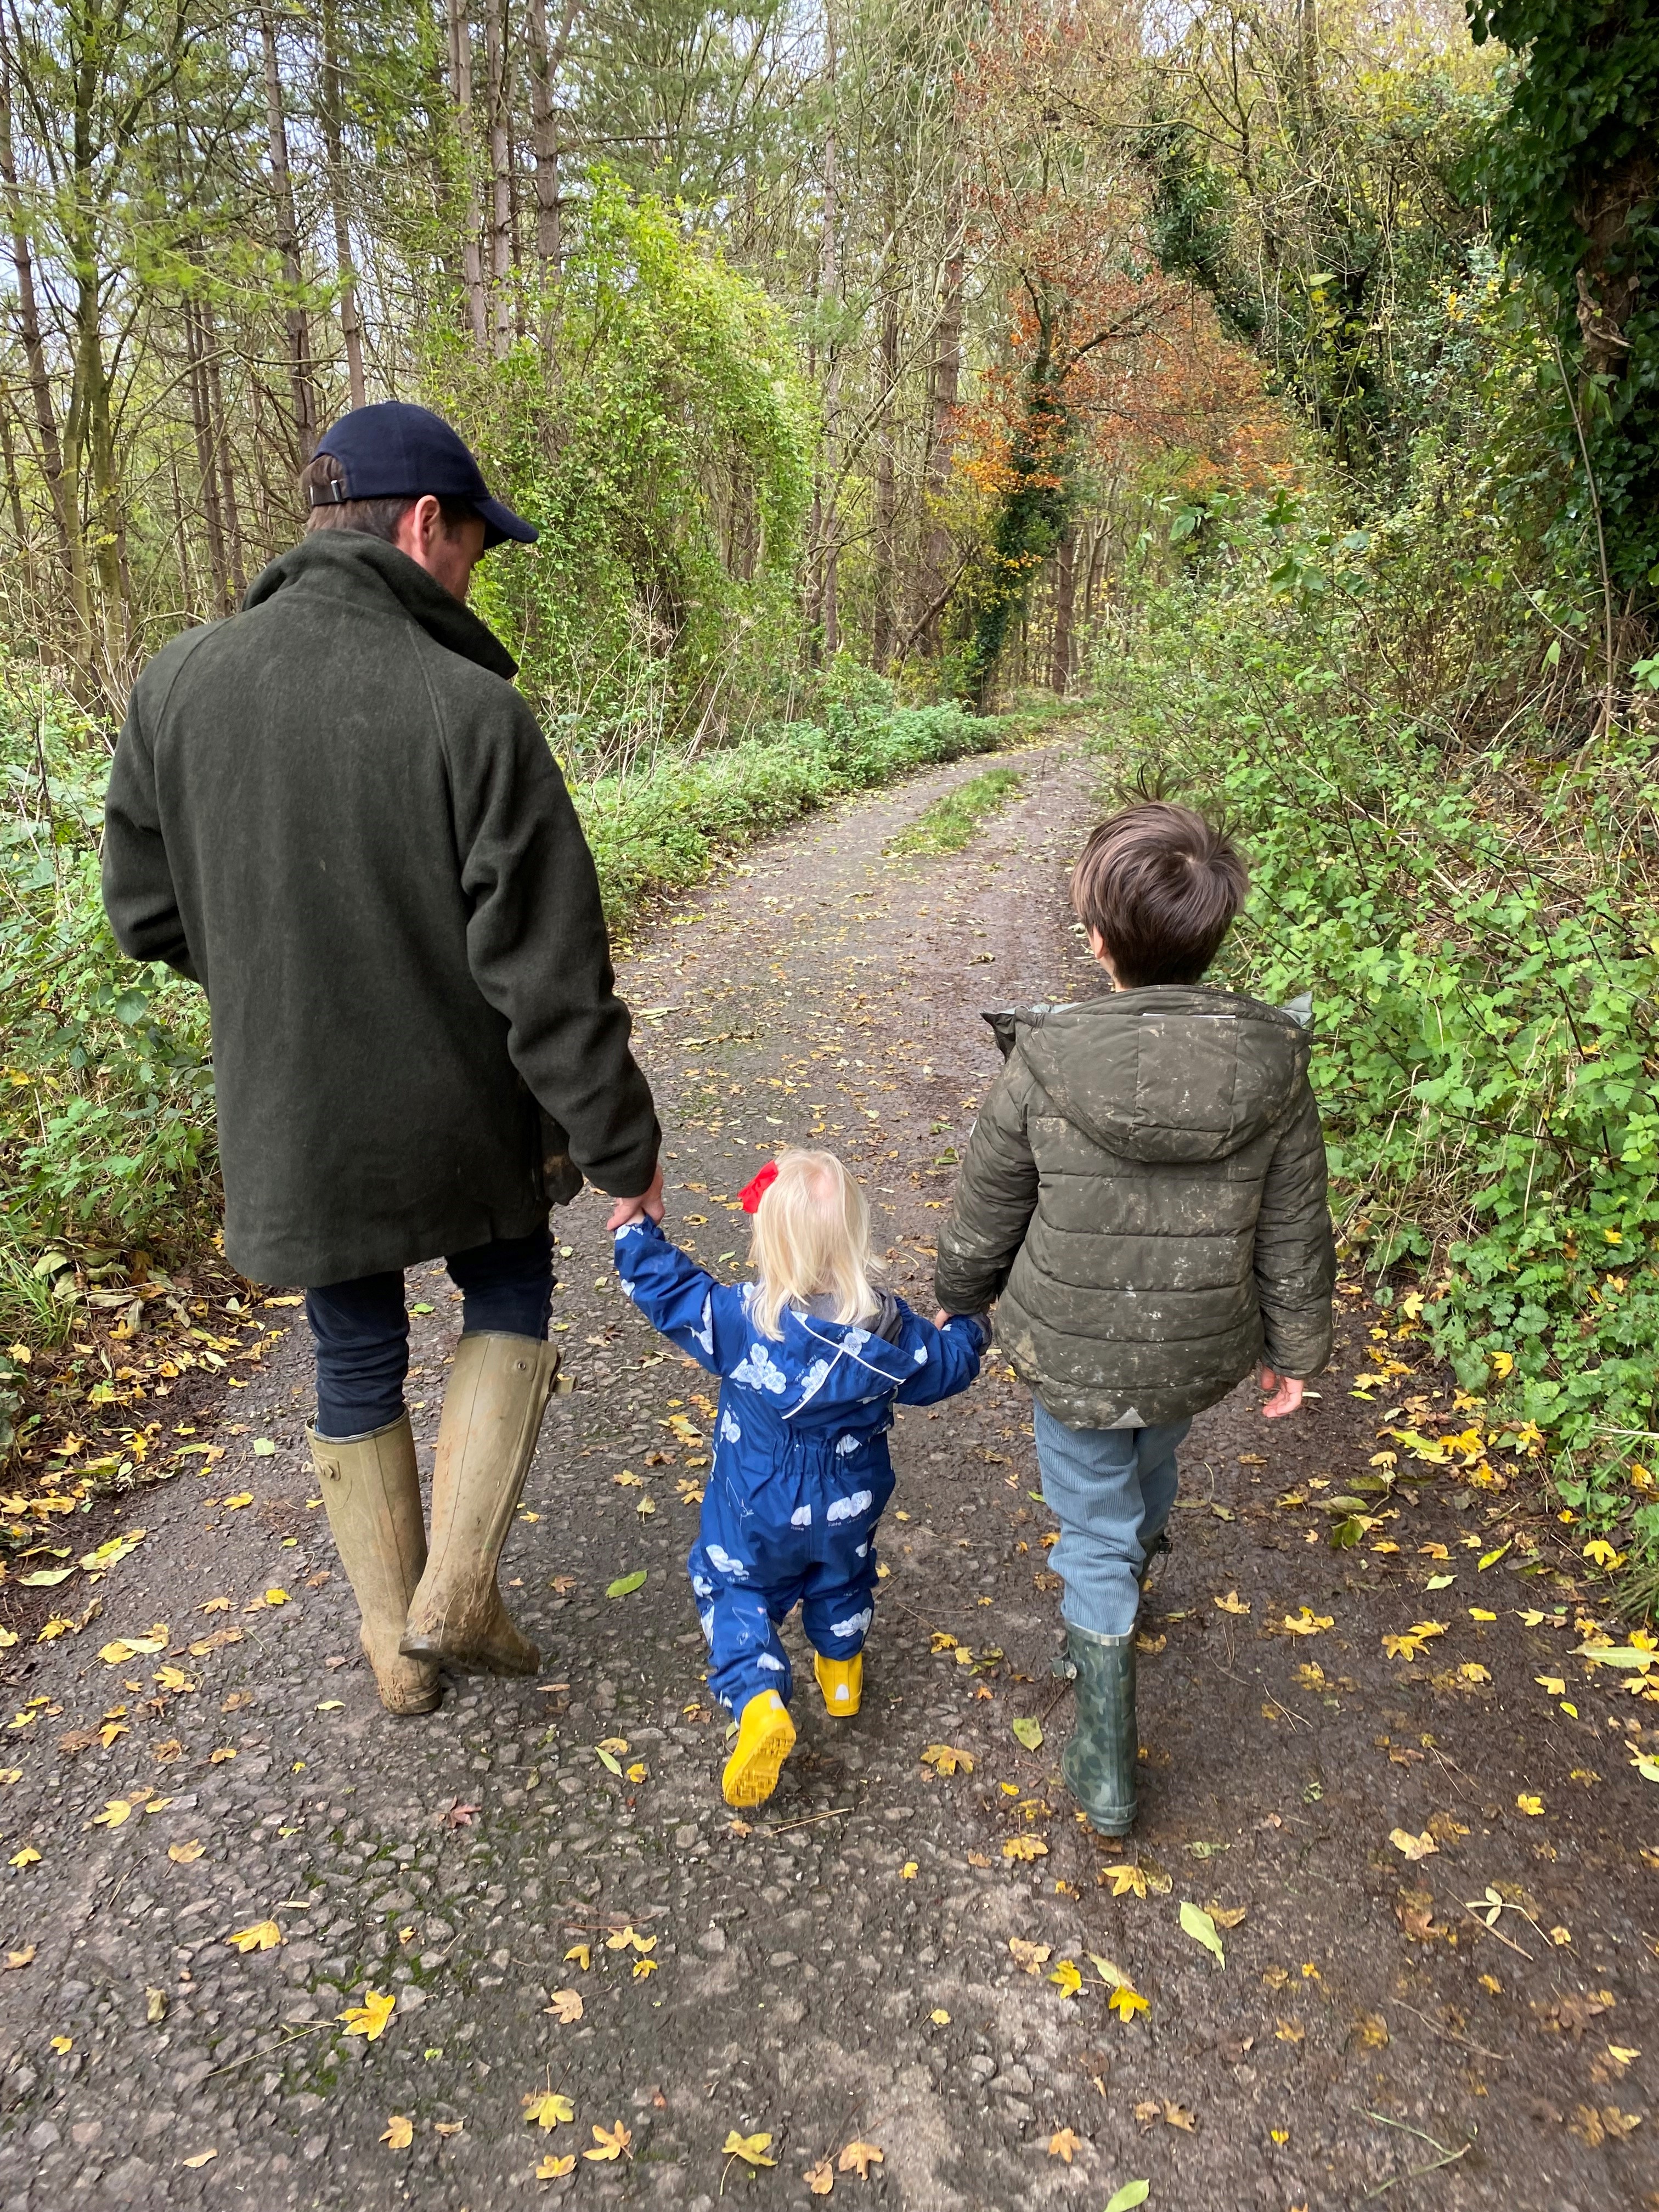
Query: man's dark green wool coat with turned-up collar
104 531 657 1283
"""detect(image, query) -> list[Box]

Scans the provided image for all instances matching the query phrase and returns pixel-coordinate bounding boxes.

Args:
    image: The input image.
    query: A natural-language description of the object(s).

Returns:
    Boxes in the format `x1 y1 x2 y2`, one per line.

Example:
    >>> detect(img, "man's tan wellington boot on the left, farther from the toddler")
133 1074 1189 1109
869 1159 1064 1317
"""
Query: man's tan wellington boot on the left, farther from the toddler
305 1413 442 1712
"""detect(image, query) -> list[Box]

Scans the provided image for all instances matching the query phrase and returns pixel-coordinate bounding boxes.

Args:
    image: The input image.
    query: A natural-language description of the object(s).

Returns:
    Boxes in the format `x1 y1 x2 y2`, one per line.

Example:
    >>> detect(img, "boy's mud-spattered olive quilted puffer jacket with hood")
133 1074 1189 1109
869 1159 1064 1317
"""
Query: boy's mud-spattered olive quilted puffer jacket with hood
934 984 1336 1429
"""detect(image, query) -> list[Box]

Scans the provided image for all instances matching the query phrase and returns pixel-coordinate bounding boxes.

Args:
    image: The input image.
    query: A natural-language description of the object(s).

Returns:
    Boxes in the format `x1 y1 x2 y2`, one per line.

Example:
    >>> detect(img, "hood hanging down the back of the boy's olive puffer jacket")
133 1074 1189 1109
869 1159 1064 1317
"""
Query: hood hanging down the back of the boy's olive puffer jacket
989 984 1307 1164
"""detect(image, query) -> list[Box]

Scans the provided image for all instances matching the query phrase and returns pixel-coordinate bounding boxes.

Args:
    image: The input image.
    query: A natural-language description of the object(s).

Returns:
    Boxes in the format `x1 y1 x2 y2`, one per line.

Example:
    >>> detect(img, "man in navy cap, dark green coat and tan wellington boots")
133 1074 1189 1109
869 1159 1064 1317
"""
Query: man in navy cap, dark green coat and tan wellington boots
104 403 662 1712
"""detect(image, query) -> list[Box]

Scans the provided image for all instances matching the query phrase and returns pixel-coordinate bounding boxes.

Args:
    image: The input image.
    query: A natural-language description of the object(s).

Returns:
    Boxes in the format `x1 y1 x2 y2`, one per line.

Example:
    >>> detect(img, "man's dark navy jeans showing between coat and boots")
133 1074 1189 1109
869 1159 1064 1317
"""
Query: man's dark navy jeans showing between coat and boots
305 1230 553 1438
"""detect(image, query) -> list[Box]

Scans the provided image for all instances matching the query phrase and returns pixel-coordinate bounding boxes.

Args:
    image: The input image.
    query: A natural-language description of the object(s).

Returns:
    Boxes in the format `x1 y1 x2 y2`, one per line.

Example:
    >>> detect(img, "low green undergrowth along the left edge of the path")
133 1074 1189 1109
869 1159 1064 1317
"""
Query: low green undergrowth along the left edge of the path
0 662 1057 1415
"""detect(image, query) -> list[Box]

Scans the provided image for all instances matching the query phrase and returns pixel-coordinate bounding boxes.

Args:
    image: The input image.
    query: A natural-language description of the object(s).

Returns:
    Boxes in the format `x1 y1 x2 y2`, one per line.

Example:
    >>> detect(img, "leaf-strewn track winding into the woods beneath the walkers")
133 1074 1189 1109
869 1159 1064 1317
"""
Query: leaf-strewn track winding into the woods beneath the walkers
0 748 1659 2212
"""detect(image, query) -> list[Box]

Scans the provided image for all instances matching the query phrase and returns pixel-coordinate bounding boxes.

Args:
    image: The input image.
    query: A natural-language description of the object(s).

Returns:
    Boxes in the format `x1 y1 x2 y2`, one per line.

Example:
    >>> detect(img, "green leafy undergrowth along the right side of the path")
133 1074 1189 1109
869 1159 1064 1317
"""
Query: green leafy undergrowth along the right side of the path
1097 527 1659 1604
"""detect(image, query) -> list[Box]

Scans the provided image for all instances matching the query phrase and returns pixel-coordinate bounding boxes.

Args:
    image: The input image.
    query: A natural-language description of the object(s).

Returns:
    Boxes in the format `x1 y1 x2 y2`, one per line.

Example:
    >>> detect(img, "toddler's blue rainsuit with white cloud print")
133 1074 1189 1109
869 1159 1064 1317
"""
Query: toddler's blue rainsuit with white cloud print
615 1221 986 1712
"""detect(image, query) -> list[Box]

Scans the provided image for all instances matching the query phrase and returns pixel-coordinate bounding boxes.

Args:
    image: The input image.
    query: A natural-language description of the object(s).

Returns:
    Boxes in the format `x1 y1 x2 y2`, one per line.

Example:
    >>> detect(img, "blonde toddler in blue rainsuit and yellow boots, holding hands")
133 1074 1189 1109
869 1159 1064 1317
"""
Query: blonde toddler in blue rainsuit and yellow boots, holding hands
615 1153 989 1805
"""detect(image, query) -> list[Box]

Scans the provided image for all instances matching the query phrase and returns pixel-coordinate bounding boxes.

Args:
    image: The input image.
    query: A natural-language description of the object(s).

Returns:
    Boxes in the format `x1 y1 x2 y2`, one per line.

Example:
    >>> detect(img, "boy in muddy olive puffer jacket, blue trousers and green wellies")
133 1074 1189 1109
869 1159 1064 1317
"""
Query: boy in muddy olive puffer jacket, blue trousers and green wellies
936 801 1336 1834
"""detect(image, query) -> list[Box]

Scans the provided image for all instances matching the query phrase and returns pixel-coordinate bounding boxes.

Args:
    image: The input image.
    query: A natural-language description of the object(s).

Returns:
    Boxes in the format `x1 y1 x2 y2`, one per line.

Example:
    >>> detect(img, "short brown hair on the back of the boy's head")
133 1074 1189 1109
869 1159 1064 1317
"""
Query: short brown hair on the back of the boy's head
1070 799 1250 991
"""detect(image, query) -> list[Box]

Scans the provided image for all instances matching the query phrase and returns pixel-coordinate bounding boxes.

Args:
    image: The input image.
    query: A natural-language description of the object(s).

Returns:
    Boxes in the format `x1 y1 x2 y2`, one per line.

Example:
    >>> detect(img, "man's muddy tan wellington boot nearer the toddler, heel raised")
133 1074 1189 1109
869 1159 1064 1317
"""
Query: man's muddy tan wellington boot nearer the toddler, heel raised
403 1329 560 1674
